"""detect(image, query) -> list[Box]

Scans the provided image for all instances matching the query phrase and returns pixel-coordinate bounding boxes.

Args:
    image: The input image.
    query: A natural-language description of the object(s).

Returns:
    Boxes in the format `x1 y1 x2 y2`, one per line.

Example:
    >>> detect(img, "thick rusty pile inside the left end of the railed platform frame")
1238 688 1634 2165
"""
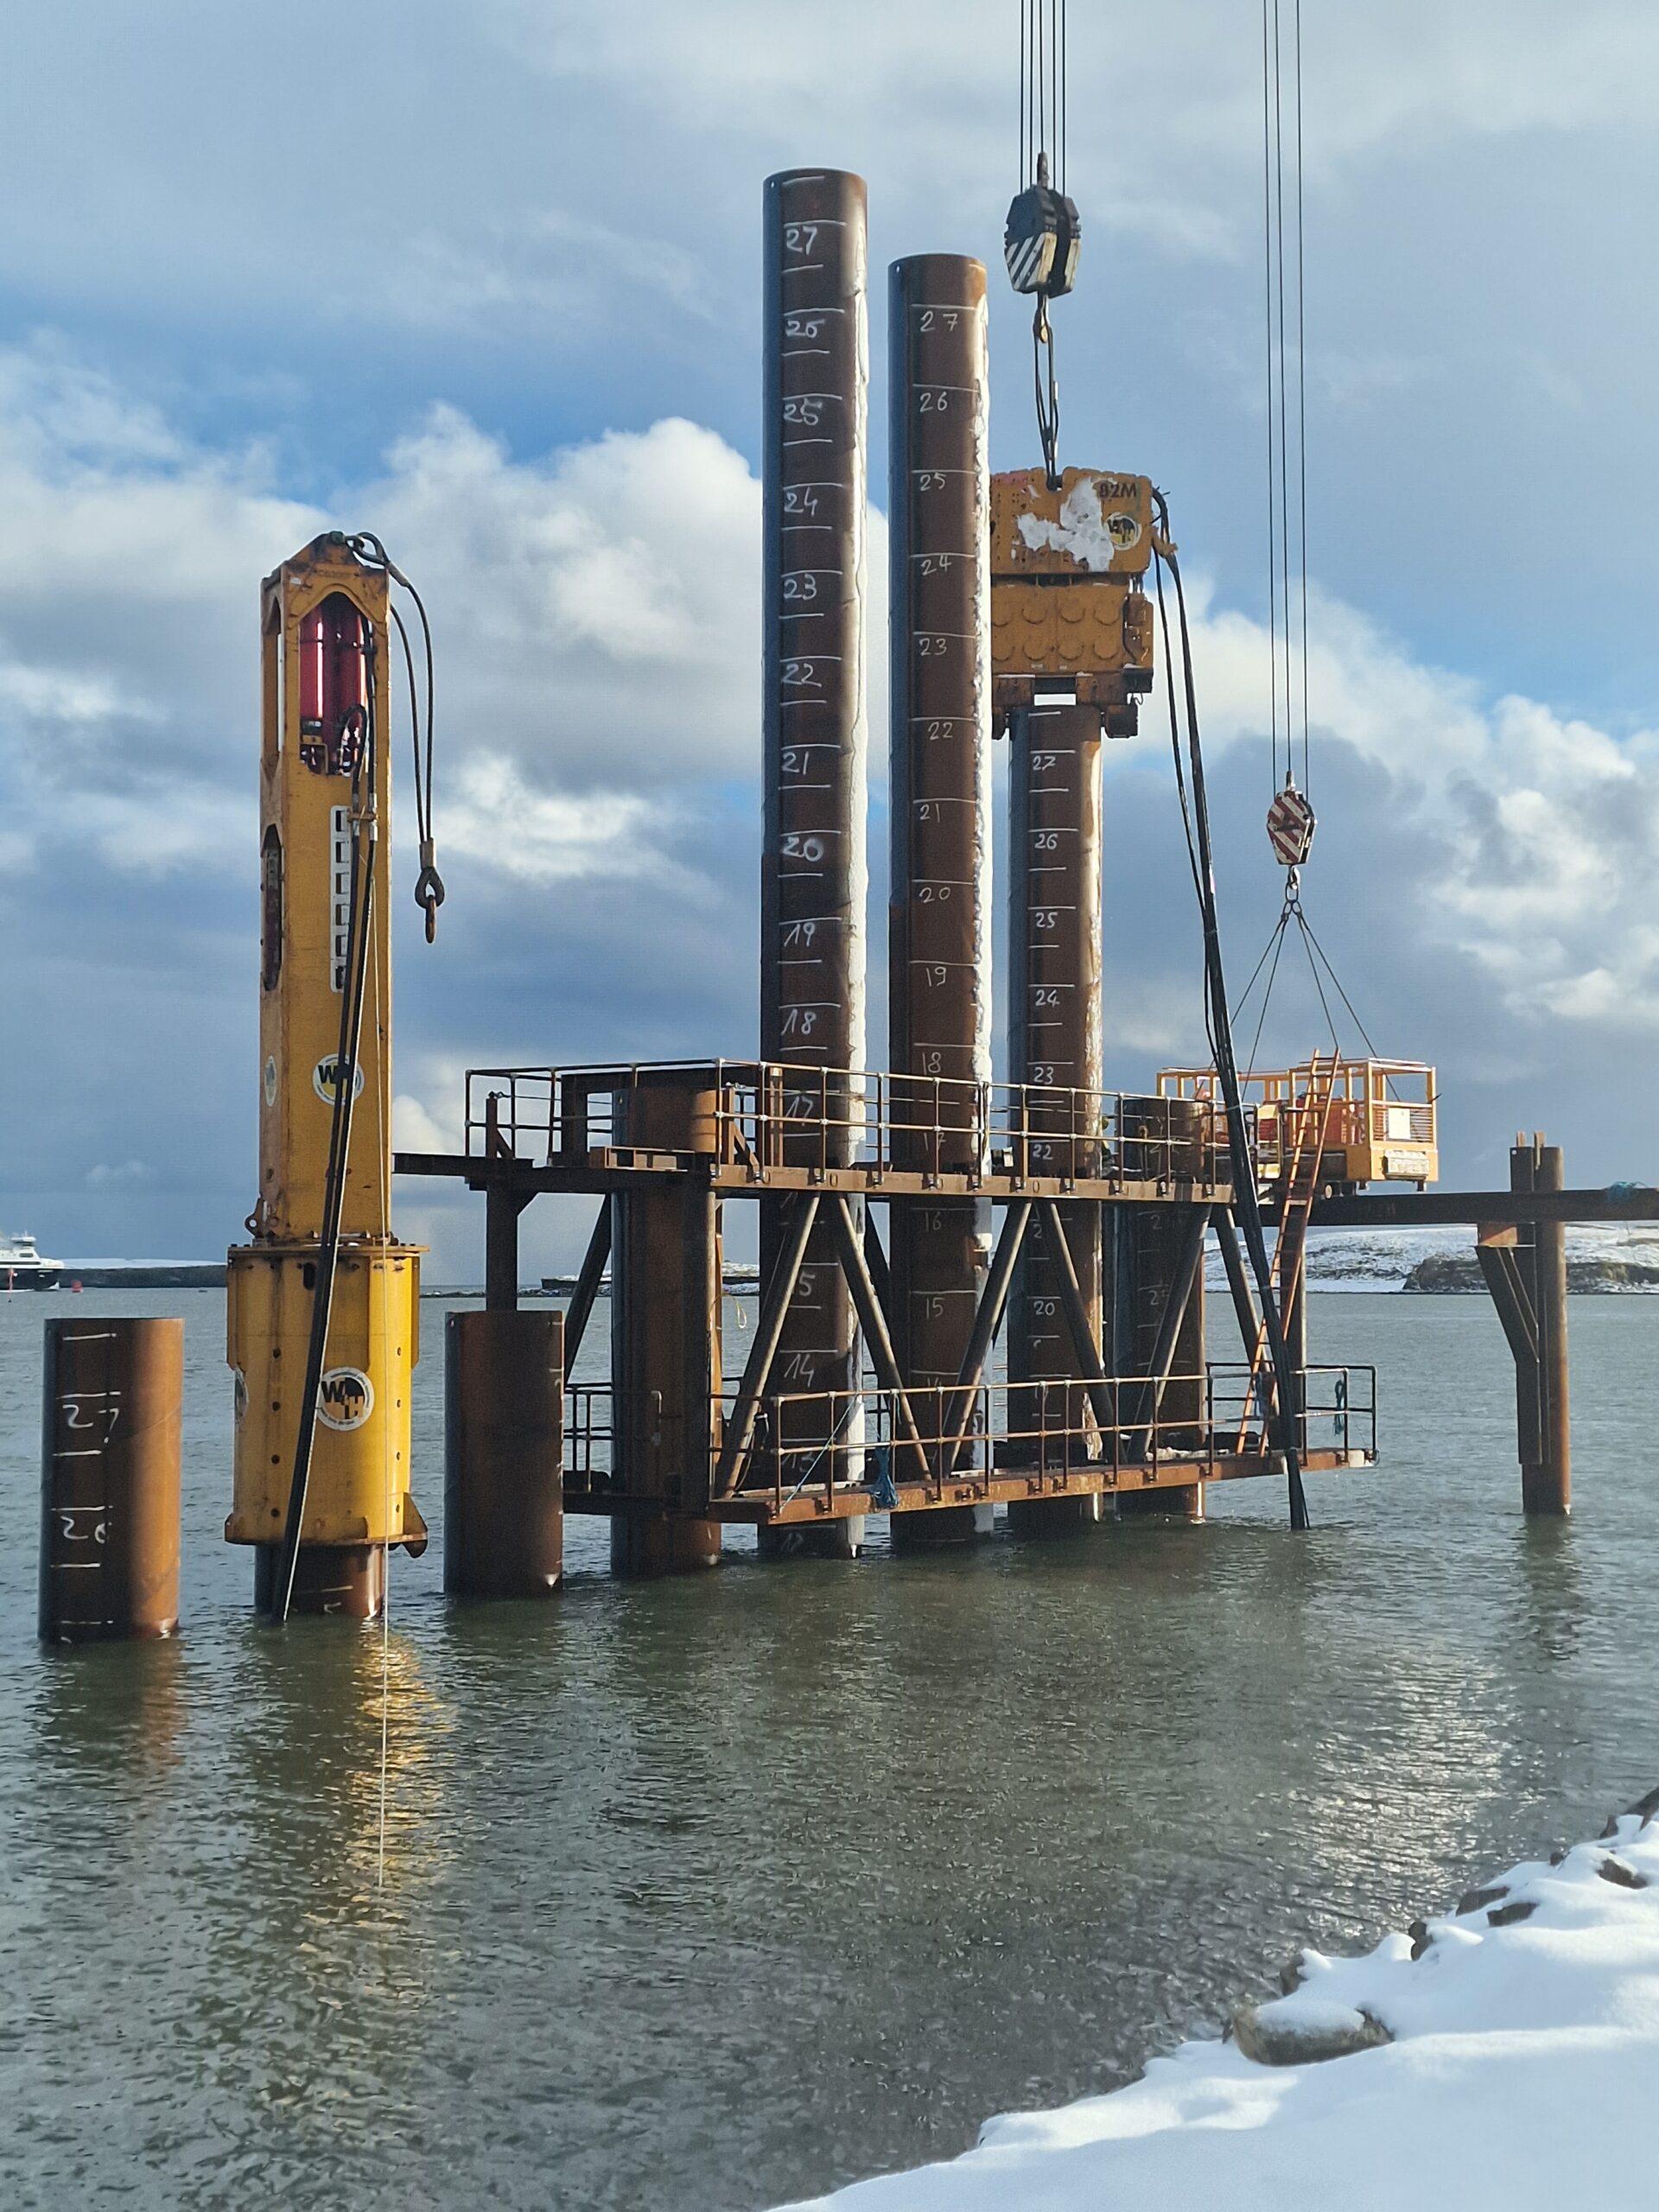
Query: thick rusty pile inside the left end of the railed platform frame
611 1086 721 1577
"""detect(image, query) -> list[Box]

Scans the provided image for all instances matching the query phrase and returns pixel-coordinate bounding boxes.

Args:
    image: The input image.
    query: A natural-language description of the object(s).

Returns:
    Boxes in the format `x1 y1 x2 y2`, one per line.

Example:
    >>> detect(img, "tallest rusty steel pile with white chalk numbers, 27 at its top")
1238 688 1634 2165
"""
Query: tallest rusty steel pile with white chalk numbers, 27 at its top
761 168 869 1478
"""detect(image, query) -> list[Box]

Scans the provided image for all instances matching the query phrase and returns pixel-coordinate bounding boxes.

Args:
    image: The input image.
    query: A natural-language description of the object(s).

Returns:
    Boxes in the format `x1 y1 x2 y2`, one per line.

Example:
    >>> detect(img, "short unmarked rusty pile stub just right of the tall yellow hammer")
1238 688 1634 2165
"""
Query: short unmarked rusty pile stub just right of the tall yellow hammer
445 1312 564 1597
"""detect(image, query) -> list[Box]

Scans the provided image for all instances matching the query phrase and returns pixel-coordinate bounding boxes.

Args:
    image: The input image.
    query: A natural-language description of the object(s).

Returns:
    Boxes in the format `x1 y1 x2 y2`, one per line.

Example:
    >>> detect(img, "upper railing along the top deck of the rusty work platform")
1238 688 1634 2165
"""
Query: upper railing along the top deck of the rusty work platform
467 1059 1230 1197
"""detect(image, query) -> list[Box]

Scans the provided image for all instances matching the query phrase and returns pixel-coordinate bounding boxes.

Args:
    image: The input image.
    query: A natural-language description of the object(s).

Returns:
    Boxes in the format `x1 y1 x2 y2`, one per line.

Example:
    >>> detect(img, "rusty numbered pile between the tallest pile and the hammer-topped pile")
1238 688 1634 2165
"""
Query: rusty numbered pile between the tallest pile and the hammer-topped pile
887 254 991 1415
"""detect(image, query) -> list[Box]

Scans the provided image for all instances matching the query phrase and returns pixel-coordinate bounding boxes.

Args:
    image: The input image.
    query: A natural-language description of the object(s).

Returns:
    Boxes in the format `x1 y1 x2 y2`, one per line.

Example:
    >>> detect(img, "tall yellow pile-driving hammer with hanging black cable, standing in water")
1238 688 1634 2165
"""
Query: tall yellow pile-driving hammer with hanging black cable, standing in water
226 533 442 1619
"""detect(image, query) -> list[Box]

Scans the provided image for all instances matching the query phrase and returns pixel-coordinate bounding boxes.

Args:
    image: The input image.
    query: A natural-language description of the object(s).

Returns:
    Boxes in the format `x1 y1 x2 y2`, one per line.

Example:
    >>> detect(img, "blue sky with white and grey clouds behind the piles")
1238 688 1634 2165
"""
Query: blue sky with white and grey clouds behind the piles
0 0 1659 1281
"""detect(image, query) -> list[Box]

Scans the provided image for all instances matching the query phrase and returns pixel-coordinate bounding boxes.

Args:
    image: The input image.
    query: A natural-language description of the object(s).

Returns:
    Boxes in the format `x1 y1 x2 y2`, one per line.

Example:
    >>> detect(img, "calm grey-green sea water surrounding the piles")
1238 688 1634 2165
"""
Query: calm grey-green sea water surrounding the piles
0 1292 1659 2212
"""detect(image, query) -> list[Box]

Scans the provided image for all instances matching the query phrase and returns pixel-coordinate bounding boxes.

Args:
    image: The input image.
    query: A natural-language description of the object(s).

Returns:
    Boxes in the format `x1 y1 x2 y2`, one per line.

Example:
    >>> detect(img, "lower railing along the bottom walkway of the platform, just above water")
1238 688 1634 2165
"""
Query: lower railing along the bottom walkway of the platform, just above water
564 1363 1376 1510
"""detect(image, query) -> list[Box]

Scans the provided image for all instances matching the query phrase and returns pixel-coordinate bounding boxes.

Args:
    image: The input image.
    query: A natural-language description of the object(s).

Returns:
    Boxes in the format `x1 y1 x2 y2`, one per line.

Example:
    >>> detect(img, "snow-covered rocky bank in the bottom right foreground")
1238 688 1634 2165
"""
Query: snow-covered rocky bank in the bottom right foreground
798 1789 1659 2212
